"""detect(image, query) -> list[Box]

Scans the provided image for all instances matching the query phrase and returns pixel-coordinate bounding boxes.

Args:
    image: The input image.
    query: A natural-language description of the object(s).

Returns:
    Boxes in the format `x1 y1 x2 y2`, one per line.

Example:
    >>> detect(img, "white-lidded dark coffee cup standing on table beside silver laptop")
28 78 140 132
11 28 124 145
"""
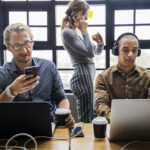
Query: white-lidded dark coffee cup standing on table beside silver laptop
92 117 107 140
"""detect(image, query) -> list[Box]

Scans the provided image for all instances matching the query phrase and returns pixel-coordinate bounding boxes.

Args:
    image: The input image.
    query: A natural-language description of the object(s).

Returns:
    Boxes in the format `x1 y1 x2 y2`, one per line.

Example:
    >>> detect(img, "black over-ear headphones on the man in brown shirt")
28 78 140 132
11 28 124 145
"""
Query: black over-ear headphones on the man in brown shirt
112 32 141 56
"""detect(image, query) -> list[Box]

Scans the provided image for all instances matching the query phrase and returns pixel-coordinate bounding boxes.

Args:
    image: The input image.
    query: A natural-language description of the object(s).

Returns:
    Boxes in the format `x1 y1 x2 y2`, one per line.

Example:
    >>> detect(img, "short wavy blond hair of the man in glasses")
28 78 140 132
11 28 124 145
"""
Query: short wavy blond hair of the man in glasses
4 23 33 46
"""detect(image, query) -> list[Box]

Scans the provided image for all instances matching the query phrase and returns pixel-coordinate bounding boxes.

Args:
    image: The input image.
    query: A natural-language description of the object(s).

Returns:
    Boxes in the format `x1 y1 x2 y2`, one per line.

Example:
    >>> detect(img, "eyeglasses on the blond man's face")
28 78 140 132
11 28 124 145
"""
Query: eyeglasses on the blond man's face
9 40 33 51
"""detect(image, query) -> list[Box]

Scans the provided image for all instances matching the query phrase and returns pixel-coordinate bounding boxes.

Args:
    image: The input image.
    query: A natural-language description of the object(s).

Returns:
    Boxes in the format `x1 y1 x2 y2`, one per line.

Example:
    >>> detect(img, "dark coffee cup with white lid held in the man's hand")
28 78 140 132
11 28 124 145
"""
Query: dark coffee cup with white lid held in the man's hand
55 108 68 127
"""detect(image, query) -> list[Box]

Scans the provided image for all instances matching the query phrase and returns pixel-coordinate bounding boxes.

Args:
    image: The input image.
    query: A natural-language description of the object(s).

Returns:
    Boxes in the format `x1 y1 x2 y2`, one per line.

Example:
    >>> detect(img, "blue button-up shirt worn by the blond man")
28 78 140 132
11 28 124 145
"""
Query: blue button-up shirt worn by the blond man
0 58 66 117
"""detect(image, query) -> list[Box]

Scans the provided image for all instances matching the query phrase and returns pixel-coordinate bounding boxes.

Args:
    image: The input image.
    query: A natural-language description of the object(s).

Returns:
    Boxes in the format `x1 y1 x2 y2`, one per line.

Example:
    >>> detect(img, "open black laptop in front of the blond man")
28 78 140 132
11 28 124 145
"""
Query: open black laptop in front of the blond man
0 102 55 139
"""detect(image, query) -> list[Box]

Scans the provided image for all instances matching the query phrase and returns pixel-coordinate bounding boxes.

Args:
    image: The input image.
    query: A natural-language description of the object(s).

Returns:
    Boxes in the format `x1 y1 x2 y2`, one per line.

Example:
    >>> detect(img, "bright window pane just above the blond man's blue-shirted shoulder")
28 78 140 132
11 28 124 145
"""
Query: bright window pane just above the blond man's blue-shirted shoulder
32 50 52 61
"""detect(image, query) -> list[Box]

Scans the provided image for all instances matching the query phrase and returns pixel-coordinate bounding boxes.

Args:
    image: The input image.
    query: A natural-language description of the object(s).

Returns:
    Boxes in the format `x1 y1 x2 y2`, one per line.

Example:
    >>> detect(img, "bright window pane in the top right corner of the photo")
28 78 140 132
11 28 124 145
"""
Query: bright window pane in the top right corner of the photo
136 10 150 23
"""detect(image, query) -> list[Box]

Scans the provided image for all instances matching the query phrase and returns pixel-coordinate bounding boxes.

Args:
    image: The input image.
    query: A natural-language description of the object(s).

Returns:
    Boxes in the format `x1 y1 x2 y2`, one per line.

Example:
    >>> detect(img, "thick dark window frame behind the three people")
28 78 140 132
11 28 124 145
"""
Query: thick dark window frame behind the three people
0 0 150 92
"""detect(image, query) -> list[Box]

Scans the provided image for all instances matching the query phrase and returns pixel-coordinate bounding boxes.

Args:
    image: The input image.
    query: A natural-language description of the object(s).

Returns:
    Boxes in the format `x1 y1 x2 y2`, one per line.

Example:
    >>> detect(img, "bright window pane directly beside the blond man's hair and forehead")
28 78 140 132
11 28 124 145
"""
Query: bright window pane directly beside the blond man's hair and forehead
31 27 47 41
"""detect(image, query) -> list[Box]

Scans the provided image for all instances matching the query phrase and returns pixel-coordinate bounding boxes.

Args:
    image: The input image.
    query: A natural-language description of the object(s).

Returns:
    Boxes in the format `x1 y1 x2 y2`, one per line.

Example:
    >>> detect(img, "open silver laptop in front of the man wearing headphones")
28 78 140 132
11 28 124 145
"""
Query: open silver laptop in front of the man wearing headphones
107 99 150 141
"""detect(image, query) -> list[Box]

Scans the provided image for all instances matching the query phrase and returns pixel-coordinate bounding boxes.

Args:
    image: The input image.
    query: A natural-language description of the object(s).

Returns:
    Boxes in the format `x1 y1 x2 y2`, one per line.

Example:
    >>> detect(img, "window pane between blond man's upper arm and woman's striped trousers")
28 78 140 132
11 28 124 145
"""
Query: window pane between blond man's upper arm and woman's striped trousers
59 70 73 89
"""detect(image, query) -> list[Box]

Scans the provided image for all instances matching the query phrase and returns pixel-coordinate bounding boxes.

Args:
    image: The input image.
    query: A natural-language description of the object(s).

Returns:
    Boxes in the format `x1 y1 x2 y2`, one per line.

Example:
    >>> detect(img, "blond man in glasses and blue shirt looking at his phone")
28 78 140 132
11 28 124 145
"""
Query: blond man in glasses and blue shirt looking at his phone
0 23 74 126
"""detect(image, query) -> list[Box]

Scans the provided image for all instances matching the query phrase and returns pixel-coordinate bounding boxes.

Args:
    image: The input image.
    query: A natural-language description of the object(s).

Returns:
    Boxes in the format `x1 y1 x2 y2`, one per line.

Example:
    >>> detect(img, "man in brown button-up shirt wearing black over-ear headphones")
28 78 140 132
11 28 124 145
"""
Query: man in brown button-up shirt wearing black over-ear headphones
95 33 150 121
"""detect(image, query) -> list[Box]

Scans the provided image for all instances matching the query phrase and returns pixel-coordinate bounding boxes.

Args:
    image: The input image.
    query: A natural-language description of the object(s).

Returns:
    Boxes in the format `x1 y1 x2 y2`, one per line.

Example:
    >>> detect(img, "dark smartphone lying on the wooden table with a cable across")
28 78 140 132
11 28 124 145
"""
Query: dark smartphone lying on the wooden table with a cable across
69 127 84 137
